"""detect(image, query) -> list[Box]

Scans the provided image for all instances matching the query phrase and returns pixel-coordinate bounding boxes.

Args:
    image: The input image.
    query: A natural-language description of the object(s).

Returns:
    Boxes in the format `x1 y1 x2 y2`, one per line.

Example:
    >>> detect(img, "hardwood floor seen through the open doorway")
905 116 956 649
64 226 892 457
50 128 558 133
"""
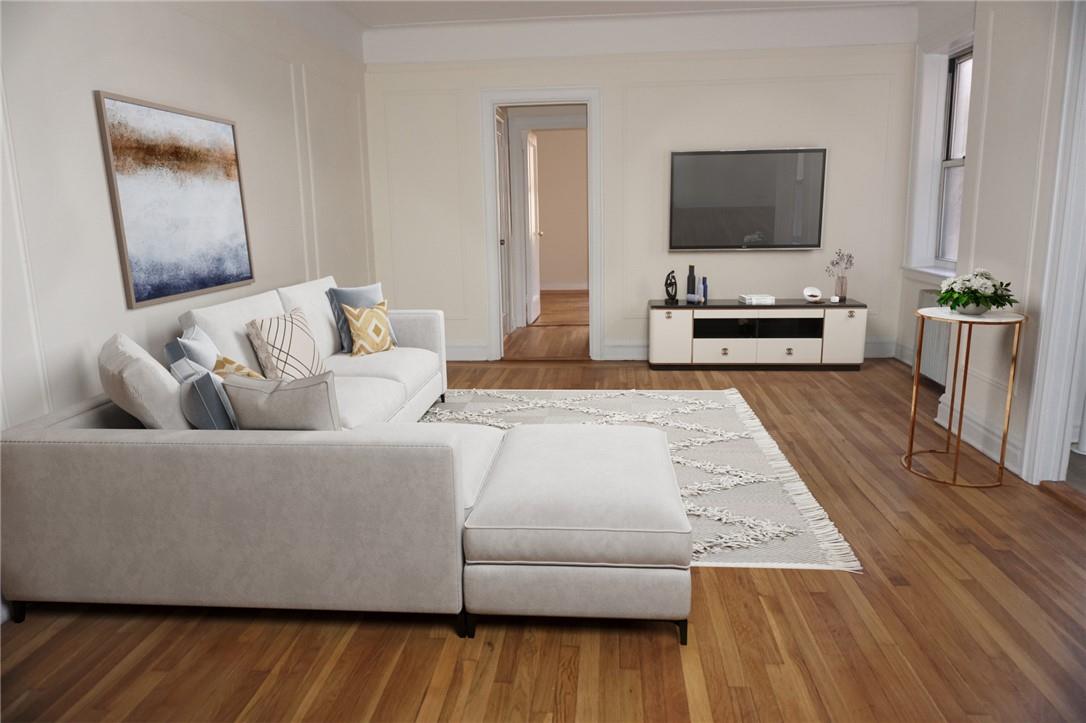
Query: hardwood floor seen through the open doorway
504 291 589 362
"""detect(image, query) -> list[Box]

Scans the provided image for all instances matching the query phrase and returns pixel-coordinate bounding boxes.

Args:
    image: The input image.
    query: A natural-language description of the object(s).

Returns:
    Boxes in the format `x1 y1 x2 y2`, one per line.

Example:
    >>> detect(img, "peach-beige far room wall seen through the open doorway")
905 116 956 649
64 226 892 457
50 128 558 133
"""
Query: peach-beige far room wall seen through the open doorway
535 128 589 291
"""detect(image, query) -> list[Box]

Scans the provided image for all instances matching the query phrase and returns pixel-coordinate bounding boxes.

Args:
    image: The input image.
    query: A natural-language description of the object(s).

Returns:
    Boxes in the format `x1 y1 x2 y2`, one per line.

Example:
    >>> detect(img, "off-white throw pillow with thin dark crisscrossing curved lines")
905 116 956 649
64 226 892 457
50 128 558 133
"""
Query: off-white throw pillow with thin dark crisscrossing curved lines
245 308 325 381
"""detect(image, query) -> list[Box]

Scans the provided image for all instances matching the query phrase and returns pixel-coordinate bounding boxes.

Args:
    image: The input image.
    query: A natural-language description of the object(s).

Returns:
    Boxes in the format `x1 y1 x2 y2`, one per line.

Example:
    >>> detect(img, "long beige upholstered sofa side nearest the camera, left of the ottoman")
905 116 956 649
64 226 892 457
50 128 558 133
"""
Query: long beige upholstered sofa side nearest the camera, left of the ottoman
0 424 477 613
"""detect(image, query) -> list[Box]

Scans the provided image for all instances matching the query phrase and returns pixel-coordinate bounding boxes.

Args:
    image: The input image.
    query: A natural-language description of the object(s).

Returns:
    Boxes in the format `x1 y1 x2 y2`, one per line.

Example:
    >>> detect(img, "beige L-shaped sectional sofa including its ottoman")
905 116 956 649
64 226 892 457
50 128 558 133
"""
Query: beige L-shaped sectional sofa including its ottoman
0 277 691 640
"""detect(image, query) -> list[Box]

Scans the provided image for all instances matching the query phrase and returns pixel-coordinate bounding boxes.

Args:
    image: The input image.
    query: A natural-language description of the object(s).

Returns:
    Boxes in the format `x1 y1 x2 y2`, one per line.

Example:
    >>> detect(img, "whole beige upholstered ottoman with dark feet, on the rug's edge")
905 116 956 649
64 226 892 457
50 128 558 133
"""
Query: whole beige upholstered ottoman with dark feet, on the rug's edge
464 424 691 645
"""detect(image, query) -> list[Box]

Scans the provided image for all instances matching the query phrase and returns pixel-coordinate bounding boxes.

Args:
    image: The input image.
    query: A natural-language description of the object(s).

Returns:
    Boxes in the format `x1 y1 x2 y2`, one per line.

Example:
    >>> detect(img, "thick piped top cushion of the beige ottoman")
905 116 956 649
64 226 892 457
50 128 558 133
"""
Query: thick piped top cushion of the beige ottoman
464 424 691 568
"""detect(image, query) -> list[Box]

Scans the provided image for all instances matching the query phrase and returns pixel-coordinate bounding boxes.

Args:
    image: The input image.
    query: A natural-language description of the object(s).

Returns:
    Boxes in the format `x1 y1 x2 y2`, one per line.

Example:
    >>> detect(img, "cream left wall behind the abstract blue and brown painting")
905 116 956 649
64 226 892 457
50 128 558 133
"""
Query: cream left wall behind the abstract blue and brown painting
2 2 372 427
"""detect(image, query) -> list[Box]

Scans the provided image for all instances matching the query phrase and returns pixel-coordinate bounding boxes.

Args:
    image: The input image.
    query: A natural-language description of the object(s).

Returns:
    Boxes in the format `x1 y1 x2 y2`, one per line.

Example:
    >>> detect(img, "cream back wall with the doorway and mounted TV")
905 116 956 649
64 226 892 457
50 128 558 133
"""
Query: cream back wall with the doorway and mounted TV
366 43 914 358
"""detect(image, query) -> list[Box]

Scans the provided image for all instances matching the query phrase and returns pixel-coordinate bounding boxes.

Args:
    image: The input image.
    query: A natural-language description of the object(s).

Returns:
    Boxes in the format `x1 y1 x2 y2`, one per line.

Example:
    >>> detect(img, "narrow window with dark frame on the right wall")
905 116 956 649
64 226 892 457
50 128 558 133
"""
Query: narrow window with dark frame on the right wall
935 50 973 265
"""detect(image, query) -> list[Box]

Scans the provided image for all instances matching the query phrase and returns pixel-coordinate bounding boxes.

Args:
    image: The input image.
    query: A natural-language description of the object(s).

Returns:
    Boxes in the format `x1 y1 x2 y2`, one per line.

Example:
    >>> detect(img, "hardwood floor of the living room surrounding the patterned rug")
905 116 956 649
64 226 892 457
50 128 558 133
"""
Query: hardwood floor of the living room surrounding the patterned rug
0 360 1086 721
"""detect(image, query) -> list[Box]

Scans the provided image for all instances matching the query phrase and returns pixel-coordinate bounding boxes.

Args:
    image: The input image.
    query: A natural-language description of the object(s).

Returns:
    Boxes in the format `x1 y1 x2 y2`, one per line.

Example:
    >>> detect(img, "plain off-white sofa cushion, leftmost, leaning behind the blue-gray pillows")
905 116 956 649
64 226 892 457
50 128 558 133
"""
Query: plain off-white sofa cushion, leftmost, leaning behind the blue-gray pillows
98 334 191 429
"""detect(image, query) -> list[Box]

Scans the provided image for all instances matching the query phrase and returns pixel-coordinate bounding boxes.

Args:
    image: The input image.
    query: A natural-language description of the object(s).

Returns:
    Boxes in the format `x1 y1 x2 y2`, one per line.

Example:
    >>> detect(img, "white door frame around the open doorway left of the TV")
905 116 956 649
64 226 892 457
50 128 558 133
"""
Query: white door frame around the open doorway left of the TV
481 88 604 360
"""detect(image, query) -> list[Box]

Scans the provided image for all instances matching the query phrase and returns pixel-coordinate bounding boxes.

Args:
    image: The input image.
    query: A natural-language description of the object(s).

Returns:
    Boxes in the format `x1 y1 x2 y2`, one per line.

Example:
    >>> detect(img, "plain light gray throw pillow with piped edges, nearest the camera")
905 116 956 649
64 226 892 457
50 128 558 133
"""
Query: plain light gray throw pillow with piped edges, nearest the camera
223 371 340 431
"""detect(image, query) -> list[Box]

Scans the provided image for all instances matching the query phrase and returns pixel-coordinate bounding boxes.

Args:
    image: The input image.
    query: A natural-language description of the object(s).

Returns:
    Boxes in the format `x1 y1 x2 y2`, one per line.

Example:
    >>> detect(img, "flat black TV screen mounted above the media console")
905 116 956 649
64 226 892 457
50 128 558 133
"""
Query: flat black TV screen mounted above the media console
670 149 825 251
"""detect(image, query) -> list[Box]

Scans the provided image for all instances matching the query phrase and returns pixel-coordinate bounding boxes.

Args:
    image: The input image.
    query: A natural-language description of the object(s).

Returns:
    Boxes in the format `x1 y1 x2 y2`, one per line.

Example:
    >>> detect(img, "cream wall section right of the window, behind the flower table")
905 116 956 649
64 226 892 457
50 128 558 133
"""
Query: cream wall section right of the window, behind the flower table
939 2 1072 471
